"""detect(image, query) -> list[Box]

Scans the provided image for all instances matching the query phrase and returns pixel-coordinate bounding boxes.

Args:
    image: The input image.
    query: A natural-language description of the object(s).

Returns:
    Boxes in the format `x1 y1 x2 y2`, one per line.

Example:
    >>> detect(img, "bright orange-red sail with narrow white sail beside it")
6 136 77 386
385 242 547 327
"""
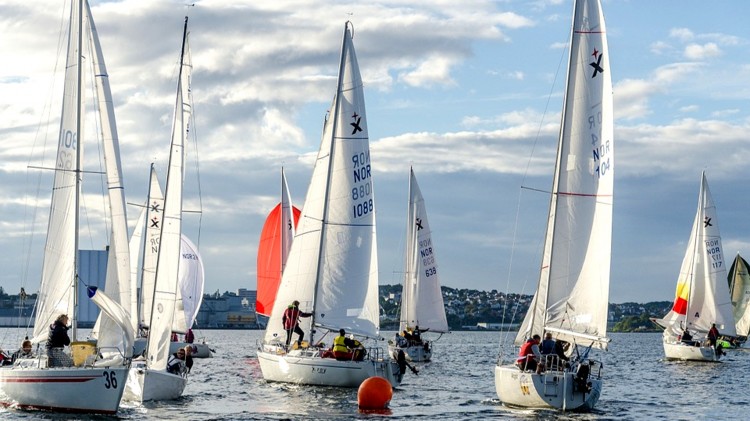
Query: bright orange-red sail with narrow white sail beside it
255 168 300 328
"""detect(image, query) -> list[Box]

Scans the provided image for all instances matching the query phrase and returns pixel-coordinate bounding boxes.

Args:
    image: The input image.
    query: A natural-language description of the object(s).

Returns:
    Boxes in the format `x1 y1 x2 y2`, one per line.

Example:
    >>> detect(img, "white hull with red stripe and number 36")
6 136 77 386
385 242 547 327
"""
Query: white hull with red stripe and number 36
0 360 128 414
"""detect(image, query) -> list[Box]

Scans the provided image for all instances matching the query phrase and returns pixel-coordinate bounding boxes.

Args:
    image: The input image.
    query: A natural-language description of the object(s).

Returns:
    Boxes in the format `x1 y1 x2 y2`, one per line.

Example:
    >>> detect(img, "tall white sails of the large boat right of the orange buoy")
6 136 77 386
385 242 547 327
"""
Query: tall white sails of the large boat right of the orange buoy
516 1 614 349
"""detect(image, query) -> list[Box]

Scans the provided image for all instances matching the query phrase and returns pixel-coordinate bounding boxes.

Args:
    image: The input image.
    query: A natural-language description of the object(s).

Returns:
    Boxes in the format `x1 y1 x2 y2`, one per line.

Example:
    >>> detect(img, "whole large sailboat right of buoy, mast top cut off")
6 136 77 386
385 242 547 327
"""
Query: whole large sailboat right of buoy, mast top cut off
495 0 614 410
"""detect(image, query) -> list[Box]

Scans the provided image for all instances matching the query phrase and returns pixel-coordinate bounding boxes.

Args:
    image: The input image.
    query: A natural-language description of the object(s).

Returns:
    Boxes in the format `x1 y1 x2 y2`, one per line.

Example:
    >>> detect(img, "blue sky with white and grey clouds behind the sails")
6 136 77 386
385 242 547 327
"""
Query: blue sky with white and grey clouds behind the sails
0 0 750 303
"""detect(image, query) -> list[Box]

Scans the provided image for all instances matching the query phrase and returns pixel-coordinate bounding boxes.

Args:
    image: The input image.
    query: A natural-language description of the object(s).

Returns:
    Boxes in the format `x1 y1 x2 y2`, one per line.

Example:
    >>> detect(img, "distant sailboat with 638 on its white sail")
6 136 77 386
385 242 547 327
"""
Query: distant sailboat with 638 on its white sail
388 168 449 362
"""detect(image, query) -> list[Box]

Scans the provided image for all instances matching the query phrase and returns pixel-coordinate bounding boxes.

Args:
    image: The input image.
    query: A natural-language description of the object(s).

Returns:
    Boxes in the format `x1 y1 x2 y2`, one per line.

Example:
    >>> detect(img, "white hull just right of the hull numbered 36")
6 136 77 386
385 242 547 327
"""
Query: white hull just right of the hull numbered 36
122 362 187 402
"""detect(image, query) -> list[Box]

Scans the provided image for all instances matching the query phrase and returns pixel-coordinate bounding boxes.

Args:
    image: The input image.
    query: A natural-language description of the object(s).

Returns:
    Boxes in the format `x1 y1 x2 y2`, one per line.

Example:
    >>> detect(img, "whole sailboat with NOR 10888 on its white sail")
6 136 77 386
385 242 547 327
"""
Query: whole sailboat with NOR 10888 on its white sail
257 22 403 387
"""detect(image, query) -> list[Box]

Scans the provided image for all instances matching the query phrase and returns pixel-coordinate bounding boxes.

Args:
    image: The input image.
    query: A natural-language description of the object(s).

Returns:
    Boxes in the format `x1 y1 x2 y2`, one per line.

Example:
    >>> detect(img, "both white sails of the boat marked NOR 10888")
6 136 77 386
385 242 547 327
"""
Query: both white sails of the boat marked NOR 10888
265 21 380 342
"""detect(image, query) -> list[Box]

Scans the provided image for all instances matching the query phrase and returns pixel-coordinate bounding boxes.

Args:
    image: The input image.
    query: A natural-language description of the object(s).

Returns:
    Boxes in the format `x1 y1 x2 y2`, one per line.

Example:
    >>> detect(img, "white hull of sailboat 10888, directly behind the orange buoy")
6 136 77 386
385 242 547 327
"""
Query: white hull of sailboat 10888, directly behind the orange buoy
258 349 403 387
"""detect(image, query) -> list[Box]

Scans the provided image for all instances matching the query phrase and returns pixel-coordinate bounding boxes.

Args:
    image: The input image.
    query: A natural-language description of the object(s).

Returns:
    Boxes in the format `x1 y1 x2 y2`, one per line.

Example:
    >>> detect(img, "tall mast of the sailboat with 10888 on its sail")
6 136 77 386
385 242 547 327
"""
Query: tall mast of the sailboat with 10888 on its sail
310 21 349 343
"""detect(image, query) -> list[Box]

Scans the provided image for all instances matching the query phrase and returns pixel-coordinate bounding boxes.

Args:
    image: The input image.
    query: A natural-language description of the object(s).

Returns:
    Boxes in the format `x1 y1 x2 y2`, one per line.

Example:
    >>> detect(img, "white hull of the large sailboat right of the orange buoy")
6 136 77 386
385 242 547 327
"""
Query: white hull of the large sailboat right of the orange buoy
495 365 602 411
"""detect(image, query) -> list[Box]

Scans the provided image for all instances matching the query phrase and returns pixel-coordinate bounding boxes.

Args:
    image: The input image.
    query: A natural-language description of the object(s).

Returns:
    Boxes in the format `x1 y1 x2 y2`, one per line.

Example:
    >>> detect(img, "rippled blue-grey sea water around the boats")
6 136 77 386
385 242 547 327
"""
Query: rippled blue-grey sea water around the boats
0 329 750 420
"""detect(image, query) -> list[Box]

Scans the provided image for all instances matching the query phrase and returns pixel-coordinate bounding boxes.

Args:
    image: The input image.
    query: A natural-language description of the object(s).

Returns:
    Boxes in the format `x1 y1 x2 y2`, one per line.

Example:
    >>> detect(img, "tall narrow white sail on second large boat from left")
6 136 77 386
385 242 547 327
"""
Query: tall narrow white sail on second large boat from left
146 23 192 370
